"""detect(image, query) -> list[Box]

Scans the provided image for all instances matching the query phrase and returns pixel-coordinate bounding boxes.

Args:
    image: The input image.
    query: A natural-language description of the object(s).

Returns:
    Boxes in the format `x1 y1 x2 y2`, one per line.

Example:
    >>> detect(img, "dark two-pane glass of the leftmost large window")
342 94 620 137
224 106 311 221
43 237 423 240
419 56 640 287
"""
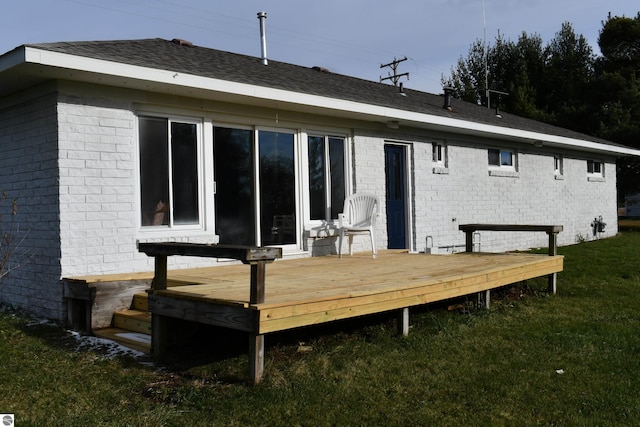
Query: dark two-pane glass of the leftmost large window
138 117 201 227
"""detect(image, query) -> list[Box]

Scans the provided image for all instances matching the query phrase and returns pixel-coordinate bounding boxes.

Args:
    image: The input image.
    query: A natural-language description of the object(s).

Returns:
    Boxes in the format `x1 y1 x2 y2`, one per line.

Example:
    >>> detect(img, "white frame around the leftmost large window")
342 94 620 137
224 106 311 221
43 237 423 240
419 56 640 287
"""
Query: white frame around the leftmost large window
135 111 204 237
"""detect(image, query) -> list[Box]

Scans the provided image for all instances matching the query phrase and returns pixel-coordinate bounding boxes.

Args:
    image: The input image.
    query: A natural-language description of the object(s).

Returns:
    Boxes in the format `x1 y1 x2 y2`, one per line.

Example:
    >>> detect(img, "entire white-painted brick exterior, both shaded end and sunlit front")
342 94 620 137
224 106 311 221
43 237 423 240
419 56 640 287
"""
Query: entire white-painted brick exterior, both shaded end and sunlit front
0 87 617 320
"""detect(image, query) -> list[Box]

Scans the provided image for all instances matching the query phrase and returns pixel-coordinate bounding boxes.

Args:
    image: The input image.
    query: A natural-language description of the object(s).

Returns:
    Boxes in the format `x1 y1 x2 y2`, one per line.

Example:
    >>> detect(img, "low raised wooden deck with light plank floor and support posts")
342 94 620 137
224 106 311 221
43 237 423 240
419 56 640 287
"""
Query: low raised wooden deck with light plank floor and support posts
149 251 563 382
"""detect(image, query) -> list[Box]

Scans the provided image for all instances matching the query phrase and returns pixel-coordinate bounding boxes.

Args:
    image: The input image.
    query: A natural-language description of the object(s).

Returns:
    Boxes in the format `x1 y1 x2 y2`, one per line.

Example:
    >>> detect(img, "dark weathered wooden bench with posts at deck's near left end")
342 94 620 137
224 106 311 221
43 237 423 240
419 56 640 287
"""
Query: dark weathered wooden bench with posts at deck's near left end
138 242 282 384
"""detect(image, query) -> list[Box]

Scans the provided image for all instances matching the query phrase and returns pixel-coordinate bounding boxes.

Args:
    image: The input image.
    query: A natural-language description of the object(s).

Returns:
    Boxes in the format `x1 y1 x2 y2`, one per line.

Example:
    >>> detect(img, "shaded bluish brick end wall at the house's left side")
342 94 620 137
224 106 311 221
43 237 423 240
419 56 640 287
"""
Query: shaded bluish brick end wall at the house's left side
0 93 64 319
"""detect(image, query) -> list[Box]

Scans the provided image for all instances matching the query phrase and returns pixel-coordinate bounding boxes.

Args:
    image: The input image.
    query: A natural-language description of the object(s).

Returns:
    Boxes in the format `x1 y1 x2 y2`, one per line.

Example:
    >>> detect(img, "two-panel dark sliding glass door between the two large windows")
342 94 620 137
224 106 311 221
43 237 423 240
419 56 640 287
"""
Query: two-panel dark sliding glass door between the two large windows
214 127 298 246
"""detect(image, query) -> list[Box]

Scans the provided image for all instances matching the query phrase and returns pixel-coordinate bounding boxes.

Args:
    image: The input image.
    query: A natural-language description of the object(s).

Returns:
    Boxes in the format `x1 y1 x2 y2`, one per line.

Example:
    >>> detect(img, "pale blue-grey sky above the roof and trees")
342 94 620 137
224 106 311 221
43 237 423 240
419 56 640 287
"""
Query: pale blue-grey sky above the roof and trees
0 0 640 93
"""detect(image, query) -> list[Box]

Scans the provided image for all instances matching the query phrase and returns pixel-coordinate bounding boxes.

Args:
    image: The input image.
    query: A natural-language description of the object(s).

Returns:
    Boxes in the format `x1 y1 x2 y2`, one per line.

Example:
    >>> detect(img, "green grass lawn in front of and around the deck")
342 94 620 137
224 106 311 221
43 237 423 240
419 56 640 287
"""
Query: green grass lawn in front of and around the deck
0 233 640 426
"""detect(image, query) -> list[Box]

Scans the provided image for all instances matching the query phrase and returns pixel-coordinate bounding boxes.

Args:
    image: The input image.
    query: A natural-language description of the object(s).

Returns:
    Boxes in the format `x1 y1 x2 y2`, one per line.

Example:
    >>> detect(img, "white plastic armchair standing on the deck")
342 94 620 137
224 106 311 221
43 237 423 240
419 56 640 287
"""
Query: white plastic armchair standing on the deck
338 194 380 258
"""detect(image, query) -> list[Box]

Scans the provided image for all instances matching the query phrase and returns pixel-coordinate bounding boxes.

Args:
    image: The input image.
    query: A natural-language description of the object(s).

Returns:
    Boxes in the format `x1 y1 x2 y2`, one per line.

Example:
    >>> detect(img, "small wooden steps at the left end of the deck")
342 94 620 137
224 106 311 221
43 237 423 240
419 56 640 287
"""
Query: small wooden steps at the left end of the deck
93 293 151 353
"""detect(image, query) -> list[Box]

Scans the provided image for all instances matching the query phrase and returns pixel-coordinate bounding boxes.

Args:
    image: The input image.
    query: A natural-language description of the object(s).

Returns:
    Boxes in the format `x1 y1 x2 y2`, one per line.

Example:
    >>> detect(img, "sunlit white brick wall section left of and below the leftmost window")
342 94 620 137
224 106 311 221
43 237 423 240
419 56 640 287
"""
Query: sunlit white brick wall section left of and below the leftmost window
58 96 222 277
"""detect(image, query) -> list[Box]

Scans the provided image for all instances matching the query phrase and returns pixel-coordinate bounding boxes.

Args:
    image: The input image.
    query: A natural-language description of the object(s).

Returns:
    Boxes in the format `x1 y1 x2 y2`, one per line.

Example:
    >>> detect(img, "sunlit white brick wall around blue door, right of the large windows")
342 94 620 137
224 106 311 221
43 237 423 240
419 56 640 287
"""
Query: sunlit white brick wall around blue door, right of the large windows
336 136 617 253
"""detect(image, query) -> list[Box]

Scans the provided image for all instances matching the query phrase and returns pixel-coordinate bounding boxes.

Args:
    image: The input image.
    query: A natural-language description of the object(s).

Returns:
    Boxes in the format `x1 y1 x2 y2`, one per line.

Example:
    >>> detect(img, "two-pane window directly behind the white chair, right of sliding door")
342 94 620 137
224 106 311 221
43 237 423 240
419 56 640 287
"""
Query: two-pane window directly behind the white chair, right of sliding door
307 135 346 221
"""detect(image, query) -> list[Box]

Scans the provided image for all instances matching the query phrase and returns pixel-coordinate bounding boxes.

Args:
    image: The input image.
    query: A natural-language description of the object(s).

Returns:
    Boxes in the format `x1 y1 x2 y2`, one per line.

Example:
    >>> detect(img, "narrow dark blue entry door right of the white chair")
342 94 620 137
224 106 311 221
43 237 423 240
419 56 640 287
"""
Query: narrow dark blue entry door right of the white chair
384 144 407 249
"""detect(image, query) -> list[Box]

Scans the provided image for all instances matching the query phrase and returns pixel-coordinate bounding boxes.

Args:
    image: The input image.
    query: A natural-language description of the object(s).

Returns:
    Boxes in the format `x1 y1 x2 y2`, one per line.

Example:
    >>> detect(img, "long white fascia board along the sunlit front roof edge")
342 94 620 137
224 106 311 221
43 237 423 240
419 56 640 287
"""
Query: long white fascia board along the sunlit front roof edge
23 47 640 156
